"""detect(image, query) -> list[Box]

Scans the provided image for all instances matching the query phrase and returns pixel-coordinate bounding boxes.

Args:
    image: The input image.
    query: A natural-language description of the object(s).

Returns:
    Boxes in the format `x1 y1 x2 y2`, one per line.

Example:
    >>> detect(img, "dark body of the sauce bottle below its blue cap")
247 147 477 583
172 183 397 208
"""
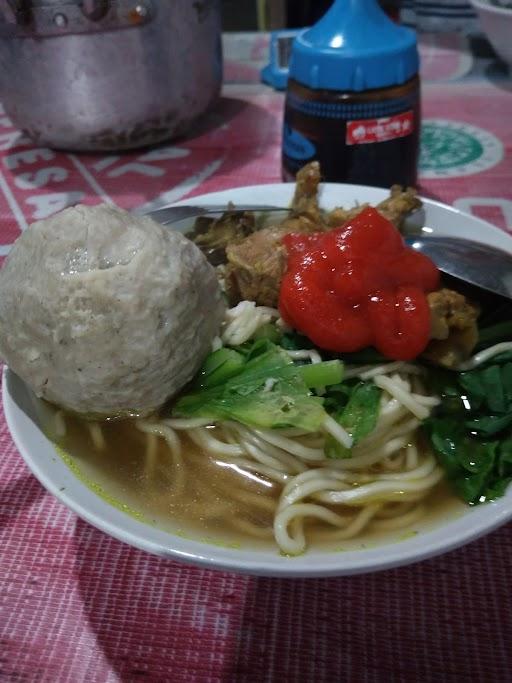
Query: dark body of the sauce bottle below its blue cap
282 76 420 187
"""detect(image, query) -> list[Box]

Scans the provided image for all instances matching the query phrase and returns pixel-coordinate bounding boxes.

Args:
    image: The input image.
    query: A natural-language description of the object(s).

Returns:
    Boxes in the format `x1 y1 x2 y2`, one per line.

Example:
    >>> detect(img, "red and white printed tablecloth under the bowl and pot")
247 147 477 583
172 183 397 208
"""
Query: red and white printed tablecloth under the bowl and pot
0 29 512 683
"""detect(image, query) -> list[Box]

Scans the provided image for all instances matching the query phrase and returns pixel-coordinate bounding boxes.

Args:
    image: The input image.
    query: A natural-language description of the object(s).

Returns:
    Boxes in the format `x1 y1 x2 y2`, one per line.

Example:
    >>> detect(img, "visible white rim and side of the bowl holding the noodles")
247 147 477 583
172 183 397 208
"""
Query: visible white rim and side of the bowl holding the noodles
3 184 512 577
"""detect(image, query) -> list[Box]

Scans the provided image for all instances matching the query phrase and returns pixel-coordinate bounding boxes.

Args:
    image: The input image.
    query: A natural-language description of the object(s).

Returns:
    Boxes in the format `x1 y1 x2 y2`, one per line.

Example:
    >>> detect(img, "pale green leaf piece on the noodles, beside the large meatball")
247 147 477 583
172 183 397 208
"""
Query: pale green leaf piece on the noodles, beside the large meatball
173 340 342 432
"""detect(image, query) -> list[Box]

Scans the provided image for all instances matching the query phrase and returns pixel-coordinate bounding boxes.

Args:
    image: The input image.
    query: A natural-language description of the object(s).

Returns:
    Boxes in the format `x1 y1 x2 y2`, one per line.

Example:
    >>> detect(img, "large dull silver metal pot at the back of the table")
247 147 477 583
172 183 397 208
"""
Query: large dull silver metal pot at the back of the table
0 0 222 150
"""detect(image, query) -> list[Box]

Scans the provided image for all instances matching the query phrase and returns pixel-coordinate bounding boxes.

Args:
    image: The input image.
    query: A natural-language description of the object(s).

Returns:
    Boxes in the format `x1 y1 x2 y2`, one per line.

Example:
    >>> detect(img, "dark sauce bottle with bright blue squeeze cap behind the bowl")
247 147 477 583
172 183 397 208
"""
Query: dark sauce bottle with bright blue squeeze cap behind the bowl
282 0 420 187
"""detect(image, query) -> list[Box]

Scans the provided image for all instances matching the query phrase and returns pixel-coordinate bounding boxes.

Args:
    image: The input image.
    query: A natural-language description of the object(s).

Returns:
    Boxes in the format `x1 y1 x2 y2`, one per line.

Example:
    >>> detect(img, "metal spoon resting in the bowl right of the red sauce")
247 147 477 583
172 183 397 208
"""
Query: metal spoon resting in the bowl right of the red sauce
405 235 512 299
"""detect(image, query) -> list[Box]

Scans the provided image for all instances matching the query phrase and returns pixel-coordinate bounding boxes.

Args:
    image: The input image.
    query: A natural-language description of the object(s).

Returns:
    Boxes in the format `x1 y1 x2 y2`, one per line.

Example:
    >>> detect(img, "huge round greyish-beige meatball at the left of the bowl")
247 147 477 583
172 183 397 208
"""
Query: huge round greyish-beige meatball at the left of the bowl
0 205 224 416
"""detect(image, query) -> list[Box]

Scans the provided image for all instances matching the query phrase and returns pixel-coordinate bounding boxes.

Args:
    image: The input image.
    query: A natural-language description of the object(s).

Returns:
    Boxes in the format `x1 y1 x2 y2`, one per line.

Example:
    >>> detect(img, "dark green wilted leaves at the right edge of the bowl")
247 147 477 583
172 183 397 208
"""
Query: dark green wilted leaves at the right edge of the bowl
426 353 512 504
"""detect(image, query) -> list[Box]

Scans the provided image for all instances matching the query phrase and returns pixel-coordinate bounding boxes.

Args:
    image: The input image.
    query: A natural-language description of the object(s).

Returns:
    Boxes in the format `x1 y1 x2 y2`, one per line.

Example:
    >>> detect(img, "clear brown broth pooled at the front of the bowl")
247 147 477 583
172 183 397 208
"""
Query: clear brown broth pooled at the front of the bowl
39 402 467 552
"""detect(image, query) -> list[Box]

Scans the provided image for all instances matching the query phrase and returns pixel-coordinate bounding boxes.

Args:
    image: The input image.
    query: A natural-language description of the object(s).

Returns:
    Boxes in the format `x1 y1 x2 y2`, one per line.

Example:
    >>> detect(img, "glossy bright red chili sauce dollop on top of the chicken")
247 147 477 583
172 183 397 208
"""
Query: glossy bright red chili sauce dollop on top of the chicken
279 207 440 360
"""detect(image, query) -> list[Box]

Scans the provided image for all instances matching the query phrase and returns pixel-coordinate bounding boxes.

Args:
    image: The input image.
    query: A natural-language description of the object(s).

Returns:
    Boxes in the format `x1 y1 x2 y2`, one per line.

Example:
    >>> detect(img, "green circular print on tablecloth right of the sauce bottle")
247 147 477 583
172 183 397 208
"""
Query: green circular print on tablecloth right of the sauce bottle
419 119 503 178
